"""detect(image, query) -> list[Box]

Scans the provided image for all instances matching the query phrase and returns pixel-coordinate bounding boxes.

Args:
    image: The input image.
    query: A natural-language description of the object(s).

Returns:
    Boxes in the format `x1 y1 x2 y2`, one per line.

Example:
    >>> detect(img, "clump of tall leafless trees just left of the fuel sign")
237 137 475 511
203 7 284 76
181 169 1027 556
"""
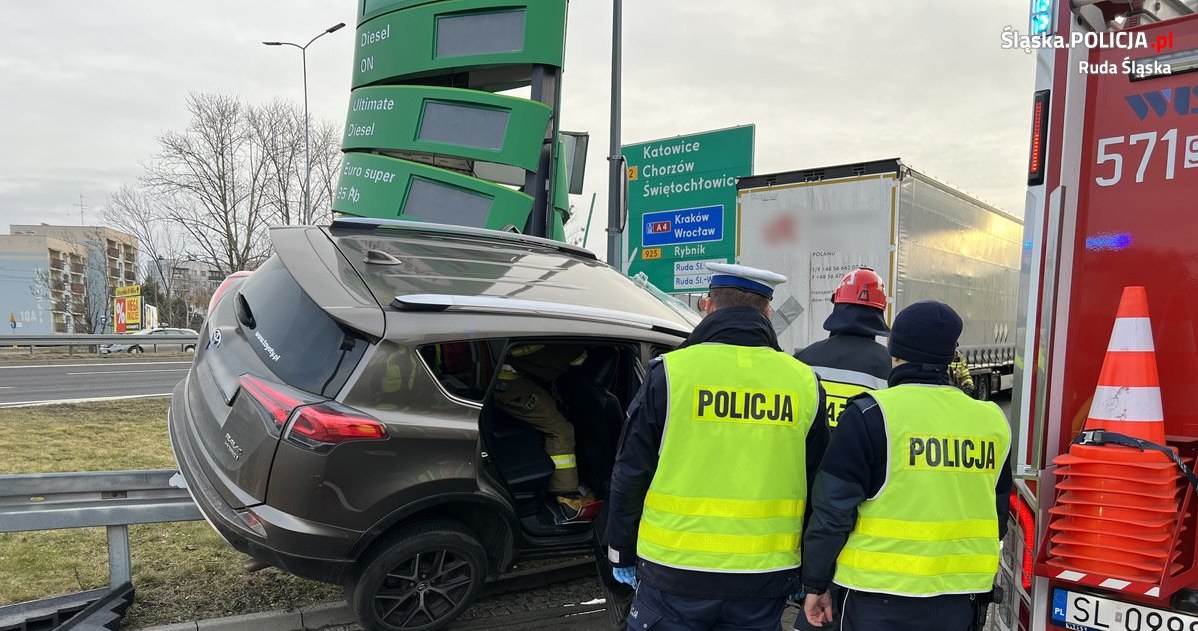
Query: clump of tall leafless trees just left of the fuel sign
119 93 341 278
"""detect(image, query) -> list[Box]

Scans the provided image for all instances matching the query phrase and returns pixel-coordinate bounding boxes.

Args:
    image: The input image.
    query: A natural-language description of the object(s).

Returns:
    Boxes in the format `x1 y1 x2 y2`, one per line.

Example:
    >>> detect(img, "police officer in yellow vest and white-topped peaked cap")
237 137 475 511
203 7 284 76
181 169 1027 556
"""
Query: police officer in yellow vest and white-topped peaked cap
607 263 828 631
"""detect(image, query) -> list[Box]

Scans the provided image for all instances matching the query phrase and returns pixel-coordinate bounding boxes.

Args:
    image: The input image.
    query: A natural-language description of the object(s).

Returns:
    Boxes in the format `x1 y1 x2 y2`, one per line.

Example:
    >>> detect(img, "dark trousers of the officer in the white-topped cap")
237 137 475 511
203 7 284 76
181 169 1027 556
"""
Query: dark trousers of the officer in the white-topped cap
628 583 786 631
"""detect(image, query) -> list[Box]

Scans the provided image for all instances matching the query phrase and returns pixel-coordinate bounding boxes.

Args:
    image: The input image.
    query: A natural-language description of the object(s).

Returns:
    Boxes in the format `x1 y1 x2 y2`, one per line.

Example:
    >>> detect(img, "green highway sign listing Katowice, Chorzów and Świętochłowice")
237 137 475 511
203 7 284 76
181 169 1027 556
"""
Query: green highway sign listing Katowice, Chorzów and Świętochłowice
623 125 755 293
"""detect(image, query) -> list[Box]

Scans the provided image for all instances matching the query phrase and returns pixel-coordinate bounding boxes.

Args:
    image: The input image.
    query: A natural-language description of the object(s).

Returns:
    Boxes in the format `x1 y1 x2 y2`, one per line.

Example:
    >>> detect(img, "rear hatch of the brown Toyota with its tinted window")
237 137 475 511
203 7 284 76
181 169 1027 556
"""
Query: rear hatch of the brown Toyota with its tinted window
179 227 383 508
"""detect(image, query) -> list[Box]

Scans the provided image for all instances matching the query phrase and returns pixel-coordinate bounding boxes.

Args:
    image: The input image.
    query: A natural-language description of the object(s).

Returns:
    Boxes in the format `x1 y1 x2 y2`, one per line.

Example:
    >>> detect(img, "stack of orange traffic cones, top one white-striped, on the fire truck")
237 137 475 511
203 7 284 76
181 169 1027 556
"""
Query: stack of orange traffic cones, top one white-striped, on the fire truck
1048 287 1181 583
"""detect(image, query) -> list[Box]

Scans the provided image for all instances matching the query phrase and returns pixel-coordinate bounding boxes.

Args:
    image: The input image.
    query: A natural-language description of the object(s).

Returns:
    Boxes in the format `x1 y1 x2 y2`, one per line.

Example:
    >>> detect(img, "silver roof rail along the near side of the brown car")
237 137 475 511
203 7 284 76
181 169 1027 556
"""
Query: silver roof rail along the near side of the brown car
391 293 690 338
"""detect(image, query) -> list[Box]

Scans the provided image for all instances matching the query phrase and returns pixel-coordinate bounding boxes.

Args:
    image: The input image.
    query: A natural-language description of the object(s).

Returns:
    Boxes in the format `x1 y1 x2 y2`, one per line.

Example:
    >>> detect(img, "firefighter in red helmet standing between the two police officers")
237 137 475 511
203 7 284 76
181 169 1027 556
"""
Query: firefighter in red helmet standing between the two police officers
794 267 890 631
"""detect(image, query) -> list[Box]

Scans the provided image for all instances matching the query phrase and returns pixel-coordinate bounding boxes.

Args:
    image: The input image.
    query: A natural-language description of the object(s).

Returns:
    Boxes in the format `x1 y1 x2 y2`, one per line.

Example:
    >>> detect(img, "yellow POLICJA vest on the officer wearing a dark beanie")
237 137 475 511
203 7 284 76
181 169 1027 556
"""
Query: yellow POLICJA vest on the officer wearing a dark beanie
834 384 1011 596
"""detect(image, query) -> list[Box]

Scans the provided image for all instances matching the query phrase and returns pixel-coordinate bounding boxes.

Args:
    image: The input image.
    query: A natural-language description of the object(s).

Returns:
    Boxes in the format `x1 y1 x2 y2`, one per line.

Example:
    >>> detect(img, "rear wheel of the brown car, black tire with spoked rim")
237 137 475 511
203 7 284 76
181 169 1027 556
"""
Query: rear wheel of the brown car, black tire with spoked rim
345 521 486 631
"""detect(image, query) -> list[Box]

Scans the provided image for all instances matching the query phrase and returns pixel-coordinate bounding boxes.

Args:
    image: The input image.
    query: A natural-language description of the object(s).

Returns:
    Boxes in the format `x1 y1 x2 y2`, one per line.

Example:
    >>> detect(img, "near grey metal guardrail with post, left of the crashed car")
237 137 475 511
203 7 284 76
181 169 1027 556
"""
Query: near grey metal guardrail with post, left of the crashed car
0 469 202 587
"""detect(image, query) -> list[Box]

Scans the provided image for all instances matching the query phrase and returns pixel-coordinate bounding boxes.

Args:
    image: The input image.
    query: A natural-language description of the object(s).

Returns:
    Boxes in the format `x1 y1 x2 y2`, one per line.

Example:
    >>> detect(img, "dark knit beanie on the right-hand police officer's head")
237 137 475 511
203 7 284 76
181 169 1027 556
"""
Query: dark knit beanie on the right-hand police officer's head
889 301 963 365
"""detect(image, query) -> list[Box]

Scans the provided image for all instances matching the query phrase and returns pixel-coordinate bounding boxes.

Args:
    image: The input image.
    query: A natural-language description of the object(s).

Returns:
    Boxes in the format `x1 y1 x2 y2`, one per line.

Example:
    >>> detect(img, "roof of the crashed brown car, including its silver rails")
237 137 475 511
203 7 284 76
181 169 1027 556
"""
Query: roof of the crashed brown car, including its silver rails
272 219 698 336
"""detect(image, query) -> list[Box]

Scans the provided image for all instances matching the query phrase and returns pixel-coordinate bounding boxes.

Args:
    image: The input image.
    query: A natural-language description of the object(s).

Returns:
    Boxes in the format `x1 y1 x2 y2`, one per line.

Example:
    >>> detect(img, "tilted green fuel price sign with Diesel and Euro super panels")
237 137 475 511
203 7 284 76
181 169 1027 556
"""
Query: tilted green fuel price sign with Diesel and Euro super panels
333 0 569 238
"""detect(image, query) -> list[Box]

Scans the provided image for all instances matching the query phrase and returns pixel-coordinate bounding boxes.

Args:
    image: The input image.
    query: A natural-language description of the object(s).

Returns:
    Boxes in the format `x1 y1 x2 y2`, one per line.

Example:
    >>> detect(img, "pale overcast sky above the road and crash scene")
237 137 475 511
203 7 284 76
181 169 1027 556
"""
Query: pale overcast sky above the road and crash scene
0 0 1034 255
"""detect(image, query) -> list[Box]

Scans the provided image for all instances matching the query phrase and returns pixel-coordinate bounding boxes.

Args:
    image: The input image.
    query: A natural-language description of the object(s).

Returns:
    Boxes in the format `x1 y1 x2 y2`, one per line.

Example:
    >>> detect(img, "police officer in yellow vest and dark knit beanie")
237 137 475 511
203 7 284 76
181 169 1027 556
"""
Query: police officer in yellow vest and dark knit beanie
803 301 1011 631
